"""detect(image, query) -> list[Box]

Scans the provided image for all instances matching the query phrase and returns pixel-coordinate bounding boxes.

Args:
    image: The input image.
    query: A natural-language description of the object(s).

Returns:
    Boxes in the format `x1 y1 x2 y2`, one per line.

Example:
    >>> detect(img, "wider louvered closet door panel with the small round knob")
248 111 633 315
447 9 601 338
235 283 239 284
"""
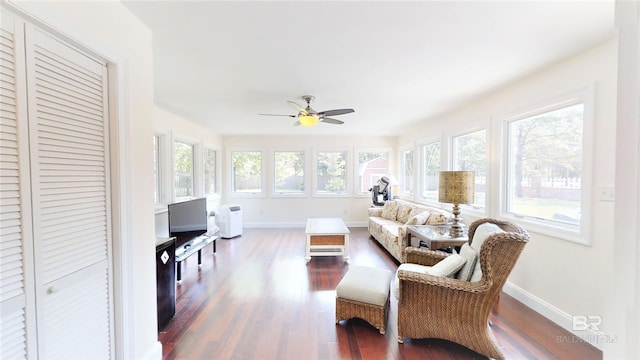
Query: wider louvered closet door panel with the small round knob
25 24 113 359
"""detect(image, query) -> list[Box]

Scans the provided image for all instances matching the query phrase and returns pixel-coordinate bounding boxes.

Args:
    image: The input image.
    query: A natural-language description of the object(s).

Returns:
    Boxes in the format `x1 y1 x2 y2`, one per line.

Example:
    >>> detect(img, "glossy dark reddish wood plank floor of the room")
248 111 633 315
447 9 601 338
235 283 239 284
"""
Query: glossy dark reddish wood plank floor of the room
158 228 602 359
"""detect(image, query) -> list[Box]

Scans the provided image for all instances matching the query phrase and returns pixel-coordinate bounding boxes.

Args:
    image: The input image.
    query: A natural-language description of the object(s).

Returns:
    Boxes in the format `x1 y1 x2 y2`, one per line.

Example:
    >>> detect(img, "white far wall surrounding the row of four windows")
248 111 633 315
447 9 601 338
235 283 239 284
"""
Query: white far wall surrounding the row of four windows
222 136 396 227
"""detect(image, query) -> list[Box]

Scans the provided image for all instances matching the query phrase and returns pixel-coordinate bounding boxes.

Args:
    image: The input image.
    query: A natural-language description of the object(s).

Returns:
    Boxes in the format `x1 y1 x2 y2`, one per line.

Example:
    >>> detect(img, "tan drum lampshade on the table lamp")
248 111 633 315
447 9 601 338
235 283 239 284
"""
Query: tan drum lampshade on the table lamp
438 171 475 204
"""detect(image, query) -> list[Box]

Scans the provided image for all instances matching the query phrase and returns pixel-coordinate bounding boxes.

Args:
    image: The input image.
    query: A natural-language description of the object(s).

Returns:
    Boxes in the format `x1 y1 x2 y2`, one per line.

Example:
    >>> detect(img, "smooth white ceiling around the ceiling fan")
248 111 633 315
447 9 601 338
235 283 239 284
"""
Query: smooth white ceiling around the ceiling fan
123 1 614 136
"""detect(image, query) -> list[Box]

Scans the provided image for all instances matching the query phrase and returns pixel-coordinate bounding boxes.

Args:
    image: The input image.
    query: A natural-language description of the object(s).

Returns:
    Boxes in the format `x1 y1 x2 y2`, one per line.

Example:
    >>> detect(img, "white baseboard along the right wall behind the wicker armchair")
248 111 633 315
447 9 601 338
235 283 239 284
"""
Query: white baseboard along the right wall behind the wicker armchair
502 282 612 350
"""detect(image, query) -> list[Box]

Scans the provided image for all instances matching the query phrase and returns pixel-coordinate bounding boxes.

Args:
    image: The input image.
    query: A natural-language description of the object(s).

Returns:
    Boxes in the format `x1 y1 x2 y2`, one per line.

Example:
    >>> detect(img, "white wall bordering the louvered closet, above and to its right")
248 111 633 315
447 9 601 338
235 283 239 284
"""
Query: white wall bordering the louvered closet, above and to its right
5 1 162 359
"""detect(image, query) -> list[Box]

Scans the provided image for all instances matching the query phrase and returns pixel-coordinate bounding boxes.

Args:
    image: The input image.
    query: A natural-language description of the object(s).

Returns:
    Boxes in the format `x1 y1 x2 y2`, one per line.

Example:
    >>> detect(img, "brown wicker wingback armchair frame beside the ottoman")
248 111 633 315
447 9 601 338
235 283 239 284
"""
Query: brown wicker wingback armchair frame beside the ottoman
397 219 529 359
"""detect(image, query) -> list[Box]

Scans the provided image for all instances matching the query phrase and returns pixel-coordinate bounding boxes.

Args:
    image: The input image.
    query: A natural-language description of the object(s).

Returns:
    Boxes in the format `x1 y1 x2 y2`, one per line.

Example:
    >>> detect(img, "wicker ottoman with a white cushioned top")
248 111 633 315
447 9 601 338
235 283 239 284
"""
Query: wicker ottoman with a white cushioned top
336 266 392 334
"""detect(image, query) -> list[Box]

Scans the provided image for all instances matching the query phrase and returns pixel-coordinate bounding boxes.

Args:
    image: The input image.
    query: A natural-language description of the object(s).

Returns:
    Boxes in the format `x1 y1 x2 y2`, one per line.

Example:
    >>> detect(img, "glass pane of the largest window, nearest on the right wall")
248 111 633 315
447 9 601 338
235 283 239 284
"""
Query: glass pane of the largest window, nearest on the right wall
507 103 584 224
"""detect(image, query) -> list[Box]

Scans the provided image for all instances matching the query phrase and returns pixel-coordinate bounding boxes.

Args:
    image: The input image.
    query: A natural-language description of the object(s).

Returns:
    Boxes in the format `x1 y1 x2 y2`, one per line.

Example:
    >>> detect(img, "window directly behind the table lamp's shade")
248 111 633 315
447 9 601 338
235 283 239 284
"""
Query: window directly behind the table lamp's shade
452 130 487 208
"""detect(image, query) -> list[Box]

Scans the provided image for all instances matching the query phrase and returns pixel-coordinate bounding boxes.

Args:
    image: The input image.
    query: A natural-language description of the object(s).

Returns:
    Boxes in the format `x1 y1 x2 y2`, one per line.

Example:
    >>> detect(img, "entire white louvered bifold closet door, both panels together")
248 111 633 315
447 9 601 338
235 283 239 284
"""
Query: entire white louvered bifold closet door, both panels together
0 13 114 359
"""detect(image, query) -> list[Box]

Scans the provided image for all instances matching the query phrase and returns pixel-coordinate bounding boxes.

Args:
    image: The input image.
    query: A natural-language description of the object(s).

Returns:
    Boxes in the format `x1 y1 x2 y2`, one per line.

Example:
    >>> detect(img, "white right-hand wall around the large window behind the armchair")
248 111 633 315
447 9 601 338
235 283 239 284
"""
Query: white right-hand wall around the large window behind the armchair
399 39 617 345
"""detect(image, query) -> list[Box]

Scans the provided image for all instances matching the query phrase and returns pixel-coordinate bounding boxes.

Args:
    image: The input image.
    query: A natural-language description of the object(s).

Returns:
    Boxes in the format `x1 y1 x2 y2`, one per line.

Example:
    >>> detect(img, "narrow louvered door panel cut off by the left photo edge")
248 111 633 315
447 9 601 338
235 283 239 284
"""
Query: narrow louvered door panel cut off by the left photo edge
0 13 34 359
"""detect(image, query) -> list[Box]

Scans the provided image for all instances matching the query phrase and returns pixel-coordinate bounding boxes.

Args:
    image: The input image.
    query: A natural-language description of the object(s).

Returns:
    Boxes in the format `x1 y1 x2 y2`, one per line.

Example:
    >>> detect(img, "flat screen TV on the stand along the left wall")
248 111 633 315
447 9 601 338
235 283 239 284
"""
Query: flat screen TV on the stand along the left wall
168 198 207 246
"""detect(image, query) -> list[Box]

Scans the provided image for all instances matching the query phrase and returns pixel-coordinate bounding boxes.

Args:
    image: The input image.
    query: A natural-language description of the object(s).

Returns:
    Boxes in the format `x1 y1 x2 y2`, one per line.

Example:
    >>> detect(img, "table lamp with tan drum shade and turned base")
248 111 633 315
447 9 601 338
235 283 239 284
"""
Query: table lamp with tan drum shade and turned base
438 171 475 238
